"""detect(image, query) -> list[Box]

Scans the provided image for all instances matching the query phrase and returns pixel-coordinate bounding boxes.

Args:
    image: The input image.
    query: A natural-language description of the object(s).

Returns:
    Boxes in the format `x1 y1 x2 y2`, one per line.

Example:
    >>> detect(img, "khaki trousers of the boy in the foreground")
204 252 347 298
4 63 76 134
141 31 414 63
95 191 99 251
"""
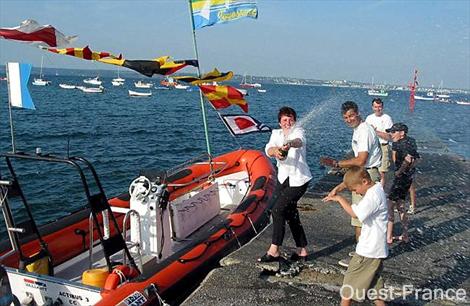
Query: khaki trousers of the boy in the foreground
341 254 384 302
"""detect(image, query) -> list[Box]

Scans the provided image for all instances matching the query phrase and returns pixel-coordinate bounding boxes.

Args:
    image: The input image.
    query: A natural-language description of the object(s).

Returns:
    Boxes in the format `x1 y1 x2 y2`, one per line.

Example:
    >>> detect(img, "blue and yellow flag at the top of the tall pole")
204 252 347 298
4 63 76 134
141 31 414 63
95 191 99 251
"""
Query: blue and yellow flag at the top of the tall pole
191 0 258 29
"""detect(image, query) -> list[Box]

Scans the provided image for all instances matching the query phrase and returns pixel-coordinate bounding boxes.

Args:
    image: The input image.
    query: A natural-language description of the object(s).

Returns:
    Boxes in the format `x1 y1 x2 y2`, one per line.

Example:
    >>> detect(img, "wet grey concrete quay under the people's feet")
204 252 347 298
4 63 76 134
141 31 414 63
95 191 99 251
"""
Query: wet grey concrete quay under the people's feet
183 154 470 305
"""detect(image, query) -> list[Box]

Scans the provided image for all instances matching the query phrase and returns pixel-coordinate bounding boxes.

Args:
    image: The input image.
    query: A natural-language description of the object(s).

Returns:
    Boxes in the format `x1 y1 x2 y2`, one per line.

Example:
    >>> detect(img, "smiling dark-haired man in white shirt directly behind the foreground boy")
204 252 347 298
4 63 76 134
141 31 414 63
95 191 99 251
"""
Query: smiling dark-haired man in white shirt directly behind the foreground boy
320 101 382 267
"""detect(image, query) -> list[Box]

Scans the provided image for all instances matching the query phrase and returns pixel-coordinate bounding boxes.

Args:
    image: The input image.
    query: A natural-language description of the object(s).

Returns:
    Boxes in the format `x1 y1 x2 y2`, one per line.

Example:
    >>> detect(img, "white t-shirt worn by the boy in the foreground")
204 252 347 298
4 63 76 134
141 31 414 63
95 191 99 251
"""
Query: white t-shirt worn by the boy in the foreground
351 183 388 258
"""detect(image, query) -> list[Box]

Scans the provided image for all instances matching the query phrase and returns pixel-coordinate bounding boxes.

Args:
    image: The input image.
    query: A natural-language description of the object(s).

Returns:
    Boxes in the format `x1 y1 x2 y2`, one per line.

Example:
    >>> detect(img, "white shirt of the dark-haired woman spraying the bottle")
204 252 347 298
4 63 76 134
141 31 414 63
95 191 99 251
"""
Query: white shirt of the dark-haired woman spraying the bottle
265 126 312 187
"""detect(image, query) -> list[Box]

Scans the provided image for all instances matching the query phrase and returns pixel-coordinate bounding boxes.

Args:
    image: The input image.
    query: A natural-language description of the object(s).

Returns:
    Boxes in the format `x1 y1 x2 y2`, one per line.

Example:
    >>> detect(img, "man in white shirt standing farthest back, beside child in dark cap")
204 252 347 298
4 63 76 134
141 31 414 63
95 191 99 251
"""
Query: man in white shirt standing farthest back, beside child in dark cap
366 98 393 186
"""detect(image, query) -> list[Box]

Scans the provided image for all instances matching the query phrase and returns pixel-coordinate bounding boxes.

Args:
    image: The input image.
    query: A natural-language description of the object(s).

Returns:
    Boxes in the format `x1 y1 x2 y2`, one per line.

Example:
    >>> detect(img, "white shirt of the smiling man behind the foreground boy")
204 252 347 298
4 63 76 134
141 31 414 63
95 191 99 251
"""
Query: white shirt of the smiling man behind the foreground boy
351 121 382 168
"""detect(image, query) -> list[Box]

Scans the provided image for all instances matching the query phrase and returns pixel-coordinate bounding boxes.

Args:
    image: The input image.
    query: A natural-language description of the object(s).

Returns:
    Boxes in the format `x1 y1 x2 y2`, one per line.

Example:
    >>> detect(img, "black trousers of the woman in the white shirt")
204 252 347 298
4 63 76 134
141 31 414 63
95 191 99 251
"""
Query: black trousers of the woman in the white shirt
272 178 309 248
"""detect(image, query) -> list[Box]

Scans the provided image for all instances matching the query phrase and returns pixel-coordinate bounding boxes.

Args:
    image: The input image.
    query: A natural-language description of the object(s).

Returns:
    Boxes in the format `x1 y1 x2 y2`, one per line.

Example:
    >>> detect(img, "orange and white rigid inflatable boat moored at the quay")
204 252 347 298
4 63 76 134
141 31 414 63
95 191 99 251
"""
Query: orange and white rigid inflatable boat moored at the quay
0 2 276 306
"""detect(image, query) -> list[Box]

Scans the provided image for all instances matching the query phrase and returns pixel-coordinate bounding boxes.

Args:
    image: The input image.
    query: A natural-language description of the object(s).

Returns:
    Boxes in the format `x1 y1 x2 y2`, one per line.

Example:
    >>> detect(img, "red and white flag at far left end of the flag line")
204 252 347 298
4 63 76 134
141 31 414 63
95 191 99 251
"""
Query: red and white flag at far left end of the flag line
0 19 77 48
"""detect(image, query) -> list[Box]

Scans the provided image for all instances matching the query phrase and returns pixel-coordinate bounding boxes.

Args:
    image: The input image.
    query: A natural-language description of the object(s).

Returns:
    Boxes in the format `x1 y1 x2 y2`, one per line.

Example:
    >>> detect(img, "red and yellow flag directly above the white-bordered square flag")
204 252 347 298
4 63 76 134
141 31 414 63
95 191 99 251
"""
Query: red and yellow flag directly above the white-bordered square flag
199 85 248 113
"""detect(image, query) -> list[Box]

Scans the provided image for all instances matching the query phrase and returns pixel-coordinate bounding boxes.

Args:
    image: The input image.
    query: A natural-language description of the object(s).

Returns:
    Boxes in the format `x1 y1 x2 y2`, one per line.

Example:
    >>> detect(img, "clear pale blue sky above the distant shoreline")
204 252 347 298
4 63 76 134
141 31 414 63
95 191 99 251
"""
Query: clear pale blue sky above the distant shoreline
0 0 470 89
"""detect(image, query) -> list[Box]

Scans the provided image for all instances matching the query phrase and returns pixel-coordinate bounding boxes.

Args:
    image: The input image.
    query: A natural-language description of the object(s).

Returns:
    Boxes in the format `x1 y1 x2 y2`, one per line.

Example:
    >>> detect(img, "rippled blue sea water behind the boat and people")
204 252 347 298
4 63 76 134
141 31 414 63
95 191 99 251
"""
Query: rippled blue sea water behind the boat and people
0 76 470 232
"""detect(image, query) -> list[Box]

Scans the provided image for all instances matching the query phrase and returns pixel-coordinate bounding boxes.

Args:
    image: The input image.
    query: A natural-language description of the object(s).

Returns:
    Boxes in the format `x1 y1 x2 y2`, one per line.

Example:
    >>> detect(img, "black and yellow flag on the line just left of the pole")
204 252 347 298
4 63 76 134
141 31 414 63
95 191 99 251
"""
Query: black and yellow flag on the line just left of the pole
98 56 198 77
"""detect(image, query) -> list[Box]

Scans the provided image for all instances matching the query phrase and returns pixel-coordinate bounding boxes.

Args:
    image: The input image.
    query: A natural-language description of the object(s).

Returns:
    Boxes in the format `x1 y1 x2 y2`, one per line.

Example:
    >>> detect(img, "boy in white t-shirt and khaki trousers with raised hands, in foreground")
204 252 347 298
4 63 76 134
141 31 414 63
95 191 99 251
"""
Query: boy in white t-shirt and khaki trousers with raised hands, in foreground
323 166 388 305
